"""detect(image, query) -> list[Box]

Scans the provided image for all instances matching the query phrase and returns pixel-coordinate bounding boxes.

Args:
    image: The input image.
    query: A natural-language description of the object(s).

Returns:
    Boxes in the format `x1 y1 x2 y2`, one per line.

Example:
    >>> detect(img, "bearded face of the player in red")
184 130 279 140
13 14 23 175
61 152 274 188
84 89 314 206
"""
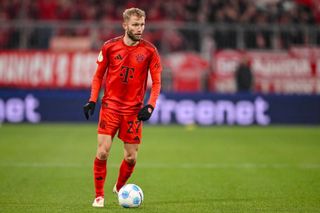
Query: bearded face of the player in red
124 16 145 41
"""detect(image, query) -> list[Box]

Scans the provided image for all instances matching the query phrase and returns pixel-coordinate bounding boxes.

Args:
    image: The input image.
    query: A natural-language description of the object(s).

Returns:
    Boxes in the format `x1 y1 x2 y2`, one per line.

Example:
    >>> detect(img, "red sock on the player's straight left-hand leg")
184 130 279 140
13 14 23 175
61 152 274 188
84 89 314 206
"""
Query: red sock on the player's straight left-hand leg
93 158 107 197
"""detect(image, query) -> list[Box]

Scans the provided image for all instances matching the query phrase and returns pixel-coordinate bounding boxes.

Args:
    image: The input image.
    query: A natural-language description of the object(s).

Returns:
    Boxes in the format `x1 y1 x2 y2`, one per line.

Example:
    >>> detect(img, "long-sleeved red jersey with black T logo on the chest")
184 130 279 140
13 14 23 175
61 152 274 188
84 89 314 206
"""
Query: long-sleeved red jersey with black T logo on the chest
90 36 162 114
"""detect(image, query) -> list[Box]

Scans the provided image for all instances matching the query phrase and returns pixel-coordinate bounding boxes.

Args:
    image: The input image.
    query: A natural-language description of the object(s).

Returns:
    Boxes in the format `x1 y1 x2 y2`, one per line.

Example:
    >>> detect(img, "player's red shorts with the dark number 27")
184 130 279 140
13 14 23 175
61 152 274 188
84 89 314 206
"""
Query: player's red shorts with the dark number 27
98 108 142 144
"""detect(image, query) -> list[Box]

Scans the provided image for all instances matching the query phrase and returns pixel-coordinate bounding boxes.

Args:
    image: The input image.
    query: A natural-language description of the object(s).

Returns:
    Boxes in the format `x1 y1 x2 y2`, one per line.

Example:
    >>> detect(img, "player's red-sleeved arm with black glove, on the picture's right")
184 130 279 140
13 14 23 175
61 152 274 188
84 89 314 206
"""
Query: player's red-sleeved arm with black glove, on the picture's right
138 49 162 121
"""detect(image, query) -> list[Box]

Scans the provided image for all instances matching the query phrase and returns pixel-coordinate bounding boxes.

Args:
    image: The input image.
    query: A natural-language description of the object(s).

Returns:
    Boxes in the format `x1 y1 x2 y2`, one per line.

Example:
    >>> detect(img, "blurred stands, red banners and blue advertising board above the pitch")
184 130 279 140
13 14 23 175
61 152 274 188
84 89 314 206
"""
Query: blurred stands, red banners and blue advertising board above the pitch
0 0 320 125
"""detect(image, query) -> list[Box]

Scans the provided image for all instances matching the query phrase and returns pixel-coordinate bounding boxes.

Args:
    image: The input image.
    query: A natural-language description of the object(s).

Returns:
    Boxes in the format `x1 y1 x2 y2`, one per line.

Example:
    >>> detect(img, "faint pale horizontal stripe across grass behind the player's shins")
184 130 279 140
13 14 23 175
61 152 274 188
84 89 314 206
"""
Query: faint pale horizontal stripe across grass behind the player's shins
0 162 320 170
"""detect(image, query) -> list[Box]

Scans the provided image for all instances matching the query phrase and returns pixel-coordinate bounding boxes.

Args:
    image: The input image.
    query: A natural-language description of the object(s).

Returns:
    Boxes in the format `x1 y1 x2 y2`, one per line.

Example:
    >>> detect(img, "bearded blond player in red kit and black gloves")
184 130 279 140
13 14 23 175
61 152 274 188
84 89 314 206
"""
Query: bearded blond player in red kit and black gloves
83 8 162 207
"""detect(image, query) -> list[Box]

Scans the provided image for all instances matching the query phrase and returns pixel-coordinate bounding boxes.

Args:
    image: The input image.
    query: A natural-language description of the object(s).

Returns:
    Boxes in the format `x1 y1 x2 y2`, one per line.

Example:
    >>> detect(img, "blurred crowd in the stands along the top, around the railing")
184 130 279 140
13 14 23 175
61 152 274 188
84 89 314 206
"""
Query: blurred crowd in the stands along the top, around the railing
0 0 320 51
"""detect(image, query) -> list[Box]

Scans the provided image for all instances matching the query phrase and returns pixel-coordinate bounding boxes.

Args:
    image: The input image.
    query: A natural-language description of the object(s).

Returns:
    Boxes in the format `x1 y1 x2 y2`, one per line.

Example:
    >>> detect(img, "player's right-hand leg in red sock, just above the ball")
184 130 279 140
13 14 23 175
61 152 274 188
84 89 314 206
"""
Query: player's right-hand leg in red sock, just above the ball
116 143 139 191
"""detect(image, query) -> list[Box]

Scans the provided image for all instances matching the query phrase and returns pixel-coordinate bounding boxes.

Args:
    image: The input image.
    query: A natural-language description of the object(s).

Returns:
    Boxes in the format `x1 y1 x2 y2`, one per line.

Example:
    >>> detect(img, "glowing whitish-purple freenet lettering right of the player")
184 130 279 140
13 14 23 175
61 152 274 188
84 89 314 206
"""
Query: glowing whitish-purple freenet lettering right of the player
149 95 271 125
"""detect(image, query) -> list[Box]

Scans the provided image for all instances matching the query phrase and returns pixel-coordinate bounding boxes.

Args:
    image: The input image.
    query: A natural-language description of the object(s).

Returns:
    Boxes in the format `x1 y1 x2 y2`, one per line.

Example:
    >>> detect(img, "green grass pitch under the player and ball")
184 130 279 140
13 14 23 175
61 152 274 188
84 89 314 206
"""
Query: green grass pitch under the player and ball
0 124 320 213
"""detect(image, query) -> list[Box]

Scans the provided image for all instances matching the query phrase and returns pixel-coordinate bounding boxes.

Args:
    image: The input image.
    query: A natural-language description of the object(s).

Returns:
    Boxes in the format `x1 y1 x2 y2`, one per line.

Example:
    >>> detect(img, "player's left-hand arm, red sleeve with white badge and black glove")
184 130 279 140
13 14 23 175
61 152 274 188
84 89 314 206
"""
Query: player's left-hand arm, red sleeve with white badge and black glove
83 47 108 120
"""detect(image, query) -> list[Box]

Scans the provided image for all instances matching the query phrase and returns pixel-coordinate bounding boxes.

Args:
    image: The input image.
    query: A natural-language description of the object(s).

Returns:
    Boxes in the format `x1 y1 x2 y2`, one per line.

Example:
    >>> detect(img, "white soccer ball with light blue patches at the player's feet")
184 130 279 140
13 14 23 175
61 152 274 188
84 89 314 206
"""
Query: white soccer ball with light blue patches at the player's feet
118 184 143 208
